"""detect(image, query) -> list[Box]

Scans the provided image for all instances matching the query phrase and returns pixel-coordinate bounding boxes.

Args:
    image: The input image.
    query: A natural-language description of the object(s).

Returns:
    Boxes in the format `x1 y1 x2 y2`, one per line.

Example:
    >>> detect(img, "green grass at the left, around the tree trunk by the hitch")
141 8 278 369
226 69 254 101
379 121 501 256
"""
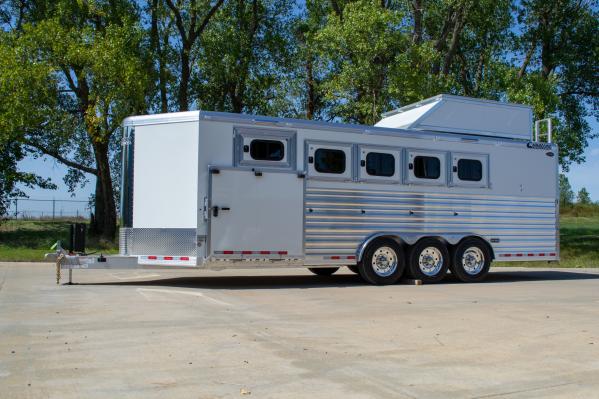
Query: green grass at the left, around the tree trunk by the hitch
0 220 118 262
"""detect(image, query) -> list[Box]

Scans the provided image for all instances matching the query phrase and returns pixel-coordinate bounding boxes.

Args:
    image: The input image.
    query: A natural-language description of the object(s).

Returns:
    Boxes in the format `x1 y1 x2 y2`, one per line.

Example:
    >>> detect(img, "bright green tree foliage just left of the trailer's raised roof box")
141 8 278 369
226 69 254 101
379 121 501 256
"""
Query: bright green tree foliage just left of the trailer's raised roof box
316 0 410 124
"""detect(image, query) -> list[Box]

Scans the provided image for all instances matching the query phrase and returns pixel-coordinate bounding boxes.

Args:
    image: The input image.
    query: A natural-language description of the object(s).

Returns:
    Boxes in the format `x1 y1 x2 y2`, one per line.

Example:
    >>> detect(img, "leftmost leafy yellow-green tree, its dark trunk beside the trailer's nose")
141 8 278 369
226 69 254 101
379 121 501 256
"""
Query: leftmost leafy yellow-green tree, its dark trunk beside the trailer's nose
0 1 153 238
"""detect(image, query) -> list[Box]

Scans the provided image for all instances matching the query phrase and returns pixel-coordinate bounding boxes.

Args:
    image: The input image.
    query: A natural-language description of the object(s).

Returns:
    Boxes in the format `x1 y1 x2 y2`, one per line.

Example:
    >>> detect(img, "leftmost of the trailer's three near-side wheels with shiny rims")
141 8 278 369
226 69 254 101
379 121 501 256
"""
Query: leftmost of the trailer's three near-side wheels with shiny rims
358 238 406 285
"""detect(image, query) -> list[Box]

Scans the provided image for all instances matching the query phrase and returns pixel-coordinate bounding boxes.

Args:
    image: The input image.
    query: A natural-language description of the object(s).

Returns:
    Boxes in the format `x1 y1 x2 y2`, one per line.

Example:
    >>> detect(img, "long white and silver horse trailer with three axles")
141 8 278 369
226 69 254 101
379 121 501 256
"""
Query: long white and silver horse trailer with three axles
49 95 559 284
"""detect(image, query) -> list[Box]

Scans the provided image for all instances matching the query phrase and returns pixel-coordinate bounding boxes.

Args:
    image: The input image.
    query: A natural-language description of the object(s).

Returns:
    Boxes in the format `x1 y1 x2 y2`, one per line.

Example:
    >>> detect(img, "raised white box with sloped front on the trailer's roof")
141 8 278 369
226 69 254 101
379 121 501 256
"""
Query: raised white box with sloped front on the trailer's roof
375 94 532 141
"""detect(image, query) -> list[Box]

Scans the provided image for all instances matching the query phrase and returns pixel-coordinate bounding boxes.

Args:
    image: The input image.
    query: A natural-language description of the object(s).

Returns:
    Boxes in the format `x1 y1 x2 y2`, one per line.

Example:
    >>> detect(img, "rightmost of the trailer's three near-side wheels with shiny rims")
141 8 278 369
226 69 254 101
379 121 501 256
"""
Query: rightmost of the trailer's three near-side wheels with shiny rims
450 237 492 283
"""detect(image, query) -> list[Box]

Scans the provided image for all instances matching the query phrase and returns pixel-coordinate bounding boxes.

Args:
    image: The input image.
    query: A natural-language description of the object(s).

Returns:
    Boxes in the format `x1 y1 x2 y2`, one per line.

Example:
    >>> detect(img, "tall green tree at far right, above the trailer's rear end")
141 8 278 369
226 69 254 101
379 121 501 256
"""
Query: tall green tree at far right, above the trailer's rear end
510 0 599 170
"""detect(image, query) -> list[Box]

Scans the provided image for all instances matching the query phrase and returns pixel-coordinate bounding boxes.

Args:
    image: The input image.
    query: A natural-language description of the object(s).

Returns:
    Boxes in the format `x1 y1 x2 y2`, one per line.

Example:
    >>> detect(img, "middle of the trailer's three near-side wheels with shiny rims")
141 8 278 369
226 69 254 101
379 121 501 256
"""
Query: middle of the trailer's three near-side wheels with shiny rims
408 238 450 284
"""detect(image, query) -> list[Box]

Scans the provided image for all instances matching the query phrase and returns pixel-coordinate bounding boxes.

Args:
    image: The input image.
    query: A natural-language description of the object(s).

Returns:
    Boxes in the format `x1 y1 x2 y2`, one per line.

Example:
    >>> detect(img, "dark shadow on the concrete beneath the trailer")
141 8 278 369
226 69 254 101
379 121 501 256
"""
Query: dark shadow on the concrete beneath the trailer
75 270 599 290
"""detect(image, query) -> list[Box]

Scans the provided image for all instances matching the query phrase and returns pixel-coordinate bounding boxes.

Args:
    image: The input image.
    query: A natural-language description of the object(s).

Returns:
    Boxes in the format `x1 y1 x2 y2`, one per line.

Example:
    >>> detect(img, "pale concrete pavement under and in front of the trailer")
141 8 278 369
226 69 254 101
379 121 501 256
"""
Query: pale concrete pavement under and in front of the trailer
0 263 599 399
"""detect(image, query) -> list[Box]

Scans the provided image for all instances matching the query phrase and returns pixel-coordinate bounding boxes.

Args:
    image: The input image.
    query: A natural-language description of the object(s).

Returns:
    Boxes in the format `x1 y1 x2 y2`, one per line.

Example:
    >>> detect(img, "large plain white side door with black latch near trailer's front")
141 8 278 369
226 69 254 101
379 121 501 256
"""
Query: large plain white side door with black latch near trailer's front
208 169 304 259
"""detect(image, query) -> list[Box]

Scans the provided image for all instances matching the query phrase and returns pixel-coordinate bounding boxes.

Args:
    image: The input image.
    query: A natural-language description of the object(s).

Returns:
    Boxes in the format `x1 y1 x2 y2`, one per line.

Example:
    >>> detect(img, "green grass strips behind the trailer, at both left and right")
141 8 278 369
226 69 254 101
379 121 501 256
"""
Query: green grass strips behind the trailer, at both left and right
0 215 599 267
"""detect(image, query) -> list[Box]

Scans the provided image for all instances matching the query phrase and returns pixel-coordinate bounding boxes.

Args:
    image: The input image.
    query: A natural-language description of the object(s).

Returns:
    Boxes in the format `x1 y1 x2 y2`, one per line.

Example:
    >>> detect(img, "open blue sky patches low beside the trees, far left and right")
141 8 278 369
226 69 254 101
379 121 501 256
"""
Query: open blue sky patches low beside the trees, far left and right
14 120 599 209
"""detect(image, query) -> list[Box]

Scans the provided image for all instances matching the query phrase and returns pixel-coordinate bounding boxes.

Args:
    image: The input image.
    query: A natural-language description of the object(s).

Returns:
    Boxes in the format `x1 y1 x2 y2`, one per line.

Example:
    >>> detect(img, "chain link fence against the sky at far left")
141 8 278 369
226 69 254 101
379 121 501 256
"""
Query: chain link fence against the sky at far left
5 198 92 220
